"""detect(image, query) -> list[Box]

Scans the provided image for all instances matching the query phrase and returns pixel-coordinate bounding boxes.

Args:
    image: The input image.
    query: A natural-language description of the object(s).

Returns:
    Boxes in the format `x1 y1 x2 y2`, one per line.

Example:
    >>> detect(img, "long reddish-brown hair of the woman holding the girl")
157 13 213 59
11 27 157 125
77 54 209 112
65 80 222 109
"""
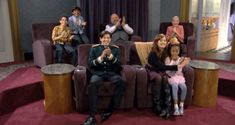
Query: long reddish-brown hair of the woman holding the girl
152 34 168 60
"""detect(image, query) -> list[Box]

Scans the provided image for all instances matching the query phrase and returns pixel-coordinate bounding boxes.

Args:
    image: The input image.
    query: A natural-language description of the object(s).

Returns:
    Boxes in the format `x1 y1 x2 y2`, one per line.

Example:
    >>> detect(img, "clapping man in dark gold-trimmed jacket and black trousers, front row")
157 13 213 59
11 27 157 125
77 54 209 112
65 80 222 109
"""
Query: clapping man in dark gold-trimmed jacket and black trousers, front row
82 31 125 125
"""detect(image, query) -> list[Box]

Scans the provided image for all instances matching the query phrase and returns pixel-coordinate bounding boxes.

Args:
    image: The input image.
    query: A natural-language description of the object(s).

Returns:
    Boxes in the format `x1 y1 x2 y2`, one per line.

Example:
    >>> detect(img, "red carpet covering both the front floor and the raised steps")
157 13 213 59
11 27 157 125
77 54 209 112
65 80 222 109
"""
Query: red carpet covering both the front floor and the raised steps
0 66 235 125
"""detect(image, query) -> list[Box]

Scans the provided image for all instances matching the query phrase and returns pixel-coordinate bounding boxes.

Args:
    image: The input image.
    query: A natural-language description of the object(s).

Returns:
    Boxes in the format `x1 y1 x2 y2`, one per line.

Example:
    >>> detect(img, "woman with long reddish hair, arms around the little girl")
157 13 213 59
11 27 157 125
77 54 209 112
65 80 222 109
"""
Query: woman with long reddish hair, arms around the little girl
146 34 188 118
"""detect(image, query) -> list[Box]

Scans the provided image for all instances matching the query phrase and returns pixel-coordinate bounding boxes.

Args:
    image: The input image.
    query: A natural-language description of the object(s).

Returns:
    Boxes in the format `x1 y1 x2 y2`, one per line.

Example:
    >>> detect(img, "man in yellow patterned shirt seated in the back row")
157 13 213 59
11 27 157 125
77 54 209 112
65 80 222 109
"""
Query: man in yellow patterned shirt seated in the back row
52 16 77 65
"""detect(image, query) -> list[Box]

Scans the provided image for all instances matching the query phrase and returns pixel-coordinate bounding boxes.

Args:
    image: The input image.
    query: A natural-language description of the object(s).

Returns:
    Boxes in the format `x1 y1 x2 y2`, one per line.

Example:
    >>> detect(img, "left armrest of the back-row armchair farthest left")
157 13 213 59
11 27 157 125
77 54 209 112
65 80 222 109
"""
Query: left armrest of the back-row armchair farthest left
32 39 53 67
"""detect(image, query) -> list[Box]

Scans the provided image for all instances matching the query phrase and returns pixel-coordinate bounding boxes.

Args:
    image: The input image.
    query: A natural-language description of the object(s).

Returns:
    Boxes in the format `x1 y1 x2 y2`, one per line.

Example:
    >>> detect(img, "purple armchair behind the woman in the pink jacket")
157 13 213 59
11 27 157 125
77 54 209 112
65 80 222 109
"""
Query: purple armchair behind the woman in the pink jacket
159 22 195 59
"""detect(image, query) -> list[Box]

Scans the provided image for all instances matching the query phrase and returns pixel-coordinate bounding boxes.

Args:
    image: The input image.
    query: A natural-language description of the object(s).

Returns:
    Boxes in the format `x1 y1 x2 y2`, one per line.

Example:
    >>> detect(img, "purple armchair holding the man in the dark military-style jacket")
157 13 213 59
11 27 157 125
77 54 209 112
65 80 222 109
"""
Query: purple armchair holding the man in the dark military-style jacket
74 44 136 113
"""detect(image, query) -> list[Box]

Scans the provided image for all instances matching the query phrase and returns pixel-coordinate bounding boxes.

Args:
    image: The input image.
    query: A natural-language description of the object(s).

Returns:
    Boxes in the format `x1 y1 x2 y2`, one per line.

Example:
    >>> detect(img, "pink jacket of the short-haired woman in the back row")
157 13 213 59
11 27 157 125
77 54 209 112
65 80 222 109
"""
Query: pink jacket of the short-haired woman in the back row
166 25 184 43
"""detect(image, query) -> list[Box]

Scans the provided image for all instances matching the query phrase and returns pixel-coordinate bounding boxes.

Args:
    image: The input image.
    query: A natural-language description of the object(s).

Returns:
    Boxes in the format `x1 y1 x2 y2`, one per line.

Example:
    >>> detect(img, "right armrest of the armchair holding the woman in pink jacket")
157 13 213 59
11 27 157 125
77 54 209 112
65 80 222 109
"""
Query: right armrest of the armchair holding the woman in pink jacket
187 36 196 59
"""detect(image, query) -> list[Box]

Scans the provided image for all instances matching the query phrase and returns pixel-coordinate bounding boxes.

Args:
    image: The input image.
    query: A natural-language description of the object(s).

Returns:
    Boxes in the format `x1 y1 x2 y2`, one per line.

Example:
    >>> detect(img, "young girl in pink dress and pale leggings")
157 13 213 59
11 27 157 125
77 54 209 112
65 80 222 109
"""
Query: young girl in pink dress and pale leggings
165 44 187 115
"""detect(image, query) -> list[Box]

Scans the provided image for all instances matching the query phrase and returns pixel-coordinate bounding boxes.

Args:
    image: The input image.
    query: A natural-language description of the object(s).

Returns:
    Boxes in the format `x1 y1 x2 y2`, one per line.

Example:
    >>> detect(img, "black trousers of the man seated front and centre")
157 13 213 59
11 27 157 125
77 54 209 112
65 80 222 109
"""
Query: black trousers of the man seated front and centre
88 74 126 116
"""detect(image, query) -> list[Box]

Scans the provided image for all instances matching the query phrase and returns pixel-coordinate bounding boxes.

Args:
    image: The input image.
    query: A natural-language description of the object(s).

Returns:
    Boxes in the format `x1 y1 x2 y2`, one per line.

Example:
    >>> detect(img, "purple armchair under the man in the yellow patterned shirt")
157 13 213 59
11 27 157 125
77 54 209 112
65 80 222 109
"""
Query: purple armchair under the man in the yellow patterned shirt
32 23 58 67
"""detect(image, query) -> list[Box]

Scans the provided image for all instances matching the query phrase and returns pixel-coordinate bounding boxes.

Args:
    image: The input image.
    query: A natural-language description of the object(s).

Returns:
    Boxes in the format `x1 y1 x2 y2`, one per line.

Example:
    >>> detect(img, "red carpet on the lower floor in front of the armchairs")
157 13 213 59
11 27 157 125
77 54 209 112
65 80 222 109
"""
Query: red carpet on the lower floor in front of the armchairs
0 96 235 125
